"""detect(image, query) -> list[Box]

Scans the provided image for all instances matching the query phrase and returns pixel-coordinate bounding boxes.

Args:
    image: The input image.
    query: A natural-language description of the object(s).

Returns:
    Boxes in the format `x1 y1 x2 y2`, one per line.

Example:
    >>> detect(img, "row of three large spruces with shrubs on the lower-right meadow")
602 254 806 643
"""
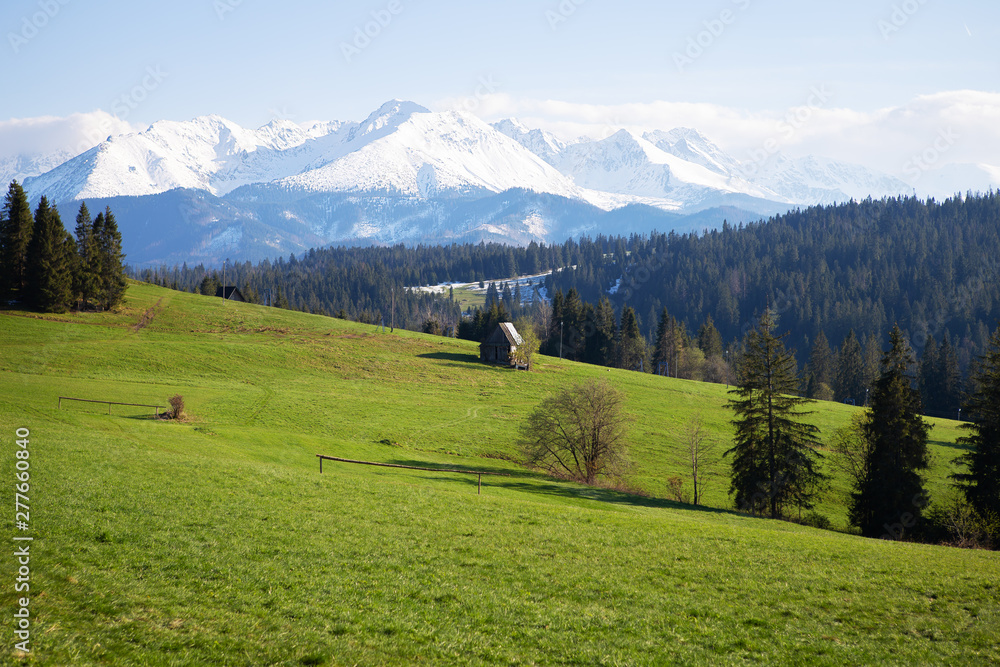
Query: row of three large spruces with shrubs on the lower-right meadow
725 310 1000 546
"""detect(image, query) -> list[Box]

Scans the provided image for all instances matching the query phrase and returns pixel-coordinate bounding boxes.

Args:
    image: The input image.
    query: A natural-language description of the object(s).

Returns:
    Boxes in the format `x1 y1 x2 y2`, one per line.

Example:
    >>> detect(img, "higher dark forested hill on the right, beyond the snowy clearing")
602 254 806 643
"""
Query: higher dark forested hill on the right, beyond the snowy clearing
548 193 1000 367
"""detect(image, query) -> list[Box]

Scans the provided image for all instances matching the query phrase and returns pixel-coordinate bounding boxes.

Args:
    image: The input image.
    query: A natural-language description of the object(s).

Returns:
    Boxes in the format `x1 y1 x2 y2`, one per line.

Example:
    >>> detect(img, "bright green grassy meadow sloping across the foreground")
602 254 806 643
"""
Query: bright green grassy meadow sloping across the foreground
0 285 1000 665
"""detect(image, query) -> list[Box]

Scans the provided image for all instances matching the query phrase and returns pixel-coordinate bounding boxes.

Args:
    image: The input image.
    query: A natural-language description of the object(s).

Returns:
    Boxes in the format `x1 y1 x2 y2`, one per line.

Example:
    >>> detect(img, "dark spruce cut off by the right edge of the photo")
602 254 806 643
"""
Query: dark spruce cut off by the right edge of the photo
953 328 1000 519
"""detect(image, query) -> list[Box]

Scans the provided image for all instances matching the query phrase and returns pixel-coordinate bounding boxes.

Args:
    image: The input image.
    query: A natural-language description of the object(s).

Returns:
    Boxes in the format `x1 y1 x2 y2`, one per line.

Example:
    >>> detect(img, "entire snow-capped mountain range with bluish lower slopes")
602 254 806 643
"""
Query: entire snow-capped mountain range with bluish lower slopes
0 100 1000 263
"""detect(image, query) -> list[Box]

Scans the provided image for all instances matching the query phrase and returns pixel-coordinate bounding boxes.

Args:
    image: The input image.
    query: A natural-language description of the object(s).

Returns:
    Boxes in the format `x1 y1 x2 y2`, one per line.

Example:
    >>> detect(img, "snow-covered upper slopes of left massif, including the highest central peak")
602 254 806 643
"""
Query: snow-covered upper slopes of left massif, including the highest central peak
28 100 585 206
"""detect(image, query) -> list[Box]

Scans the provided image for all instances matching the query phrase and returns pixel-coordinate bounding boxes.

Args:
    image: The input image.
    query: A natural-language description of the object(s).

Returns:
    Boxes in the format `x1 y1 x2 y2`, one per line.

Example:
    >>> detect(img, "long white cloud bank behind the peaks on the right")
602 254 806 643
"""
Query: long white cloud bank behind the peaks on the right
435 86 1000 183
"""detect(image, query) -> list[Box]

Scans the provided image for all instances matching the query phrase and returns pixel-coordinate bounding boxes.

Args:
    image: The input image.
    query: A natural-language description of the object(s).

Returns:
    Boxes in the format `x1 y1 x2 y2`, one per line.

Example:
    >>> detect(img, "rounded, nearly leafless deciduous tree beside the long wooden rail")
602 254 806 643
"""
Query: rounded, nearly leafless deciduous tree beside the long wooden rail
520 380 629 484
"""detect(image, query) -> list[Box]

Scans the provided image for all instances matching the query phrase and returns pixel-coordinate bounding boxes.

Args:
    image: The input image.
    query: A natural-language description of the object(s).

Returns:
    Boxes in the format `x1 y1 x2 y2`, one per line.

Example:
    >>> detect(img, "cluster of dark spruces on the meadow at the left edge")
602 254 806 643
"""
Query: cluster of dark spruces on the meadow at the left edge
0 181 126 312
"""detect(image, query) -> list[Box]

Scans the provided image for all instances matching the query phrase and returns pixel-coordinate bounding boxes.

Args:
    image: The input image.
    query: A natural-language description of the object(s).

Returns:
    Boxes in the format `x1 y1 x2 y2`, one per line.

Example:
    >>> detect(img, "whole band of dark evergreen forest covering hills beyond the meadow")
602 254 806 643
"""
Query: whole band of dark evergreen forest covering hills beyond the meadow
136 193 1000 371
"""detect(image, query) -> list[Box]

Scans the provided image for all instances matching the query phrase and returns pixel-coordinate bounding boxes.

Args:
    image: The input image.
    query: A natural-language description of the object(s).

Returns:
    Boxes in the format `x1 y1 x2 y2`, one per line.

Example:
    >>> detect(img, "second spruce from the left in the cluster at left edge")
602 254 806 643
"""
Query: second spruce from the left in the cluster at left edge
26 195 74 313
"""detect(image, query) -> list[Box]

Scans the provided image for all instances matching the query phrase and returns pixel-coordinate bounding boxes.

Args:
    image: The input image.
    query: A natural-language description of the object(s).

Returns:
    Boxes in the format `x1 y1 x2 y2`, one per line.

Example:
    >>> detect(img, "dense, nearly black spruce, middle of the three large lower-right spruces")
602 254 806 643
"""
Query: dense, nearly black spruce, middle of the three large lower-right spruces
849 325 930 539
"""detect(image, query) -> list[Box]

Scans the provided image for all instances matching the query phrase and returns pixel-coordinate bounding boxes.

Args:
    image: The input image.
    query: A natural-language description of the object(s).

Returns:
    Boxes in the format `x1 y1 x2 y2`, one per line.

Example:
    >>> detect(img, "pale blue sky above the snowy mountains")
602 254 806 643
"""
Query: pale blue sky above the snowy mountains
0 0 1000 179
